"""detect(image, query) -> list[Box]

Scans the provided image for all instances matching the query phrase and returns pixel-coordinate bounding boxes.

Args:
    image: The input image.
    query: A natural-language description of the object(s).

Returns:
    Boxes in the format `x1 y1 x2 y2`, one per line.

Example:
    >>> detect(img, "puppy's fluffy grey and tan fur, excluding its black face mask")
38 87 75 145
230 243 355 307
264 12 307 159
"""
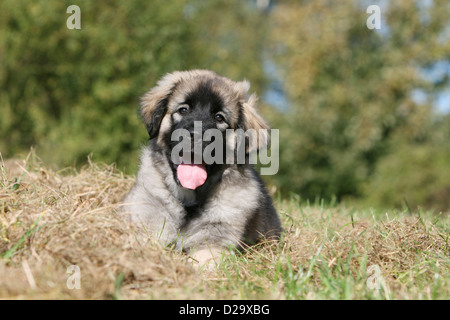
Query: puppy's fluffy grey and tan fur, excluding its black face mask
123 70 281 252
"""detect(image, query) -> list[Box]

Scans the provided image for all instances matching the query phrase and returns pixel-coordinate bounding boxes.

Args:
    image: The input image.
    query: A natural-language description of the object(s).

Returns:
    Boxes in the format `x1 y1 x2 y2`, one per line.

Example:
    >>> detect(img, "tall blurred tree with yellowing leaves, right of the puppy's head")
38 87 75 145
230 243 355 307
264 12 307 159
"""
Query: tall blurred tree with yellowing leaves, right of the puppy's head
271 1 450 210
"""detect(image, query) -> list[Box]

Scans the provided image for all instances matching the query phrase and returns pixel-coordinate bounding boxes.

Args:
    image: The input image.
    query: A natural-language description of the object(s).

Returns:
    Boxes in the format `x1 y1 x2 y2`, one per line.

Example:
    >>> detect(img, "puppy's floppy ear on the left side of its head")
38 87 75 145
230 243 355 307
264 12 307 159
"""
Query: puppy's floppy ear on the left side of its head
141 73 178 139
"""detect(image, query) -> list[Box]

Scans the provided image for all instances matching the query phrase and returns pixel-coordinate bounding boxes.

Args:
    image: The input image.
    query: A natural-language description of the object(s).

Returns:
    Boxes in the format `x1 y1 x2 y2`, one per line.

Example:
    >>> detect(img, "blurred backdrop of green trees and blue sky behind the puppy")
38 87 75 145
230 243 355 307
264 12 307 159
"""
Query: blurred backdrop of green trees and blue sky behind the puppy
0 0 450 211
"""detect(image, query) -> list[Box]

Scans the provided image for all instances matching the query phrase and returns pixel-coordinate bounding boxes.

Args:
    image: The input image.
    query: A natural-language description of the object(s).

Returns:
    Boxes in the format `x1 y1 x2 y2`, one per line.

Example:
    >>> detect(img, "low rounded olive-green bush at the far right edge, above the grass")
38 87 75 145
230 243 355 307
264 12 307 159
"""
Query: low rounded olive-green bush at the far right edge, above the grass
363 116 450 212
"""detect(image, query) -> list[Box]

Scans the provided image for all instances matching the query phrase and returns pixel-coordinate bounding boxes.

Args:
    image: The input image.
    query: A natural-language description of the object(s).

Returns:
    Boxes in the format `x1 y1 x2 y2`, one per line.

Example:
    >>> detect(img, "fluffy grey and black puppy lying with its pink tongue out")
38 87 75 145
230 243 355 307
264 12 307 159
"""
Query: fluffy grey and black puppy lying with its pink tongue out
123 70 282 265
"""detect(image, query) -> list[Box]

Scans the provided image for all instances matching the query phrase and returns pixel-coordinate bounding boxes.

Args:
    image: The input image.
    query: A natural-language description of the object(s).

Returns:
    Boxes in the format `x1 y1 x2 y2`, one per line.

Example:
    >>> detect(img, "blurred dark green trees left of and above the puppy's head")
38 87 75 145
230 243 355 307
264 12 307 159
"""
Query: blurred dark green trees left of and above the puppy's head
0 0 263 171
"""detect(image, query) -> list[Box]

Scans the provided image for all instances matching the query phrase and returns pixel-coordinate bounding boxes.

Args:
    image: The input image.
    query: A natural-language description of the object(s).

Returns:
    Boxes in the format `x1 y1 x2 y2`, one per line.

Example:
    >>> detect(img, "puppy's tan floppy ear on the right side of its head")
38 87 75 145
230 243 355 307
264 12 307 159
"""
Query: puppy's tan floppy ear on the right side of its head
242 94 270 153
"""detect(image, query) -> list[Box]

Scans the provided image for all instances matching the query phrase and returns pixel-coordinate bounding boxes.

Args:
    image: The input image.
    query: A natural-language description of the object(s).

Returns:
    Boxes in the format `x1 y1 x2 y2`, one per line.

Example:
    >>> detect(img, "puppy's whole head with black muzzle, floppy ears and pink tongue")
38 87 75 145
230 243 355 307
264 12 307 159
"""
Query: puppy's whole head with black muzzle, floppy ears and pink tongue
141 70 268 189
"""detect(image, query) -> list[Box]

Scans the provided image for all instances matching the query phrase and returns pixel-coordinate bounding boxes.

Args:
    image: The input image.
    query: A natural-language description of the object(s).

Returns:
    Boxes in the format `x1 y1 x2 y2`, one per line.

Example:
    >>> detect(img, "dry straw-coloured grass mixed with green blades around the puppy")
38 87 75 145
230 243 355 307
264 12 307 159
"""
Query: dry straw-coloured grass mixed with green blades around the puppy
0 153 450 299
